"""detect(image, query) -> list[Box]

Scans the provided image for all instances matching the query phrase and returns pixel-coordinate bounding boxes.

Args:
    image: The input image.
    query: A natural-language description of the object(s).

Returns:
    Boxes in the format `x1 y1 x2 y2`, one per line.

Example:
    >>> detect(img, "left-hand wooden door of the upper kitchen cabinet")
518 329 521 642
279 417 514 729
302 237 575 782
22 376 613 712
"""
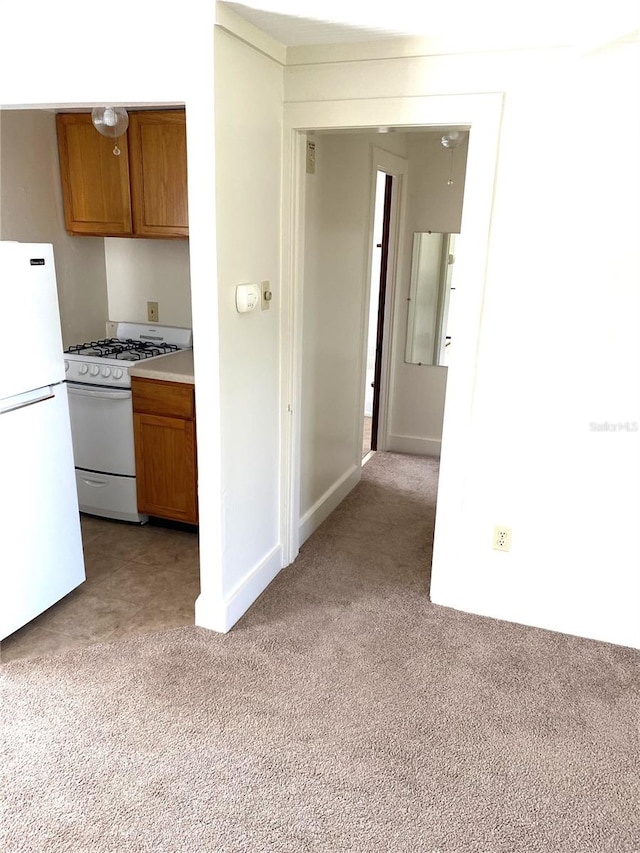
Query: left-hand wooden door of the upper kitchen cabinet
56 113 132 236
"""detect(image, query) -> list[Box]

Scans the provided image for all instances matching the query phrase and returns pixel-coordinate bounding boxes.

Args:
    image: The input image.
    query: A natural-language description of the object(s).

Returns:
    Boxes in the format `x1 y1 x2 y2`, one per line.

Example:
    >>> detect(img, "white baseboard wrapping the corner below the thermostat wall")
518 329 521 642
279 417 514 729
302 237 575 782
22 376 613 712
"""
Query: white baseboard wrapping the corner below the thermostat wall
196 545 283 634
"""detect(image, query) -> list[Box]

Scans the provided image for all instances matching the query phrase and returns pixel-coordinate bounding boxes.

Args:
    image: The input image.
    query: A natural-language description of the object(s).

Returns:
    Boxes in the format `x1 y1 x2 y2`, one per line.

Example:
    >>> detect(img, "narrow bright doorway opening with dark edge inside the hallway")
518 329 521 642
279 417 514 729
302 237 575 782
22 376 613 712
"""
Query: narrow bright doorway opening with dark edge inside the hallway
362 169 393 460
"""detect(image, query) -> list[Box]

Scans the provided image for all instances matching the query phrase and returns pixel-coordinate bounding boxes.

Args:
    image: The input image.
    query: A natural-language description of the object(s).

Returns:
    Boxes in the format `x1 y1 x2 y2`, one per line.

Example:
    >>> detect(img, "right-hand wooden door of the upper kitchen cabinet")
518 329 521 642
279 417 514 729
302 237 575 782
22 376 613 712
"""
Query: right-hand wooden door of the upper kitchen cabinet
129 110 189 237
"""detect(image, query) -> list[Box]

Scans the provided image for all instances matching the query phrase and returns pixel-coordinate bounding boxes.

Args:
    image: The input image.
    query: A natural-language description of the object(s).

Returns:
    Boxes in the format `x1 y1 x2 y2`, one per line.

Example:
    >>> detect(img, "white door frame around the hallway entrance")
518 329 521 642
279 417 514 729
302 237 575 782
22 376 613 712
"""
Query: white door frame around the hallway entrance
280 93 503 570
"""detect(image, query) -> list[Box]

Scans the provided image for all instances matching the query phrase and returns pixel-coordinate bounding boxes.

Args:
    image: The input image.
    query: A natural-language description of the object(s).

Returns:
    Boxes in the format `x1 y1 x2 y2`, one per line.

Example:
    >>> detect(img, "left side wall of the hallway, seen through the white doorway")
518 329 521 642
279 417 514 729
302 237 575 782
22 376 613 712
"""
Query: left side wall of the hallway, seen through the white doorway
300 134 405 542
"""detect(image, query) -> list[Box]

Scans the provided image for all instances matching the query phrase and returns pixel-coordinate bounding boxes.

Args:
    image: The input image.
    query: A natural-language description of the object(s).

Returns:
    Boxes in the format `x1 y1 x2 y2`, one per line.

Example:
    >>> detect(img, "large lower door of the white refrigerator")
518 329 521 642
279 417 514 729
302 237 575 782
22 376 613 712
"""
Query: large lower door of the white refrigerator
0 384 85 639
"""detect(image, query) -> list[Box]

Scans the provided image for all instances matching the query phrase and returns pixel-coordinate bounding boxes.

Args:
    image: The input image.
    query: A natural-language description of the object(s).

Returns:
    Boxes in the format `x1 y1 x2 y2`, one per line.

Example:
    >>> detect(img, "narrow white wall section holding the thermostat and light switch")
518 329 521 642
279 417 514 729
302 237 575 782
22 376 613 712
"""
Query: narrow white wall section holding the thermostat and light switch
215 29 283 612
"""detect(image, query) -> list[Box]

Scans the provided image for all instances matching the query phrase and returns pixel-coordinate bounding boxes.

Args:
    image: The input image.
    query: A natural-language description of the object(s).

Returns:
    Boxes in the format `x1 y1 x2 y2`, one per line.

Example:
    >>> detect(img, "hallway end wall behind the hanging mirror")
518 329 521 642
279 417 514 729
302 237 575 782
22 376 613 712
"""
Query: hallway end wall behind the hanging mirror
384 130 467 456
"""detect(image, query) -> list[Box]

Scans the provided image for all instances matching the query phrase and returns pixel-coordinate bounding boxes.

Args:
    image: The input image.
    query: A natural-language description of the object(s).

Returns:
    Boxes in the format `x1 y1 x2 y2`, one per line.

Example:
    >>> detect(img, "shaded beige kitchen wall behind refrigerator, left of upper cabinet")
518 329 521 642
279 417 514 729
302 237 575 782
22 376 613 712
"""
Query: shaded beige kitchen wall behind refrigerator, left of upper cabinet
0 110 107 346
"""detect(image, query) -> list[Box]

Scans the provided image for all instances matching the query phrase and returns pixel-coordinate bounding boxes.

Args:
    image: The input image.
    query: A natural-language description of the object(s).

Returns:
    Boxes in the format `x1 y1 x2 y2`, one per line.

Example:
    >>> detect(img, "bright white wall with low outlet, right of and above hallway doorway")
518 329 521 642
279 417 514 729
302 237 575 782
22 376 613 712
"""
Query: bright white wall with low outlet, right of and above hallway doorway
285 43 640 646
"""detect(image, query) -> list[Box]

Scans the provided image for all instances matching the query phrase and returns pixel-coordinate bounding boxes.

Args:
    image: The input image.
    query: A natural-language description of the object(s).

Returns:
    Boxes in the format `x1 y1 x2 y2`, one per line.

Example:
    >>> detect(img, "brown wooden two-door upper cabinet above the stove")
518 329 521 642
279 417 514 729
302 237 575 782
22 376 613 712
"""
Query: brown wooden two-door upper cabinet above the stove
57 110 189 237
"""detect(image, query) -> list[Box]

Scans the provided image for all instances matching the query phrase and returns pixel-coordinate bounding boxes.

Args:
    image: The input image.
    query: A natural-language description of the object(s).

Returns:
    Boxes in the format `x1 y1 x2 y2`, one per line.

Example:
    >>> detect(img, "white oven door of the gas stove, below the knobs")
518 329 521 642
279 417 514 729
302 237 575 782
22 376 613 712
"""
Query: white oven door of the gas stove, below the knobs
67 382 136 477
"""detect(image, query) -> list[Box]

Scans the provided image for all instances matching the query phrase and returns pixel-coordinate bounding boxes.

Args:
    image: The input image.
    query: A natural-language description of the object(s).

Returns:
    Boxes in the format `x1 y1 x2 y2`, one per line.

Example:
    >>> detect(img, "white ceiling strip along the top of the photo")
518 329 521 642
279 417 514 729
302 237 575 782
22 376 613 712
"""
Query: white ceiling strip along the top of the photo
222 0 640 51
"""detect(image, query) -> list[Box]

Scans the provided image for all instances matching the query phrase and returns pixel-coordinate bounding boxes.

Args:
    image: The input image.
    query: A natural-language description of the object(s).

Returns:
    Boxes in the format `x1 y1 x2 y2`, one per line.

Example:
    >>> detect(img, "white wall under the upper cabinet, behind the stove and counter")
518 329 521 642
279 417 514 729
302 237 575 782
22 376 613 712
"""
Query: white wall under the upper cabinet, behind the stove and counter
104 237 191 327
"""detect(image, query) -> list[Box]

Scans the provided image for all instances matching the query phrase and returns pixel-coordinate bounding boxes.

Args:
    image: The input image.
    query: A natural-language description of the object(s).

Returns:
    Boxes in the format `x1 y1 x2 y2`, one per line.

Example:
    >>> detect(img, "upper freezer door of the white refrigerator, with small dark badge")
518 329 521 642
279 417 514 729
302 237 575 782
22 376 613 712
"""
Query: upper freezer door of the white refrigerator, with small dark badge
0 241 64 399
